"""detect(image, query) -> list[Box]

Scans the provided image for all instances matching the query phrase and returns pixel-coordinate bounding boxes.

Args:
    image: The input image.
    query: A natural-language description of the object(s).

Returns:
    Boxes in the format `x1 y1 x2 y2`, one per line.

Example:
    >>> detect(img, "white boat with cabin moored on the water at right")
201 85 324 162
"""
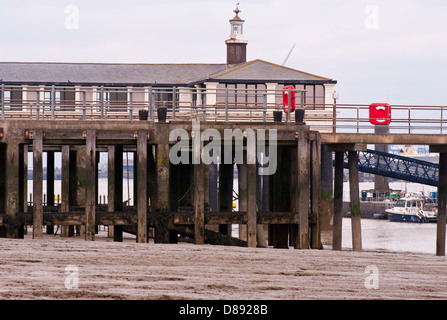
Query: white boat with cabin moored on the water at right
385 196 437 222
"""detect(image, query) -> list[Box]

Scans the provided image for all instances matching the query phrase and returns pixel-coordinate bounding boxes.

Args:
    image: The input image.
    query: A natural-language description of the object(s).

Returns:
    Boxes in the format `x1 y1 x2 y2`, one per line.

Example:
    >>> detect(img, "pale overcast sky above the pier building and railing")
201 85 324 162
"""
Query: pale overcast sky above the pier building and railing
0 0 447 105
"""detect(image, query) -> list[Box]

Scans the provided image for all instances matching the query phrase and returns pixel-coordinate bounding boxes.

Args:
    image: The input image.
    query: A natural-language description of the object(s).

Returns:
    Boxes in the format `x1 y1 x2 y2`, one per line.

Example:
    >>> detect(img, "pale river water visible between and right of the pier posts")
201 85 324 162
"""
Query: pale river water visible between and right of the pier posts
28 179 436 254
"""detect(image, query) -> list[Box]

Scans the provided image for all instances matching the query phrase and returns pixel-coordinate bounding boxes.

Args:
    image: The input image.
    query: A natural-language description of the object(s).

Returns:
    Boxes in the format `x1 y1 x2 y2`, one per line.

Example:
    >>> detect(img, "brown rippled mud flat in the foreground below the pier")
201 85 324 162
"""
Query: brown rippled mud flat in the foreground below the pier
0 236 447 300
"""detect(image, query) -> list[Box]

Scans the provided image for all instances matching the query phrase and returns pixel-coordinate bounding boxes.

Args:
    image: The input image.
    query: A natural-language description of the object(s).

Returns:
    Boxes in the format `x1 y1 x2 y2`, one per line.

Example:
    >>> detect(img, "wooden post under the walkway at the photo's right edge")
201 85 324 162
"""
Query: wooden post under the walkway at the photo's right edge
436 152 447 256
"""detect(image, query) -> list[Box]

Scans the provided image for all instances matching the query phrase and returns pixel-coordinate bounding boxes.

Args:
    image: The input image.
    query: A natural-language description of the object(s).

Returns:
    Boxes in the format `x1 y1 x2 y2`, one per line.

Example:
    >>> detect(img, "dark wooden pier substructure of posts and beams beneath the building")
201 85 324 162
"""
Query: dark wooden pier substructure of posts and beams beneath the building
0 119 321 249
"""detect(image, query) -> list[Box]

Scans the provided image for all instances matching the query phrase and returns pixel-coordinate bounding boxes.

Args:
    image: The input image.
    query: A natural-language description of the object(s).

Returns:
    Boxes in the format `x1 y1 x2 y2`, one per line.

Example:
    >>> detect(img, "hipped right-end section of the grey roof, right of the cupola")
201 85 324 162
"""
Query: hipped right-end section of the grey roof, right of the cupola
211 59 332 81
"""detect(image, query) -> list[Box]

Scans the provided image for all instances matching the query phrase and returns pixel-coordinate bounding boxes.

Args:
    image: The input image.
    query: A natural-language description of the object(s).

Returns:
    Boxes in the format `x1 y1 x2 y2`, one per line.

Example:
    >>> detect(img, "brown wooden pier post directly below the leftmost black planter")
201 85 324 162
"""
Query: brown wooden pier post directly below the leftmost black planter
134 130 148 243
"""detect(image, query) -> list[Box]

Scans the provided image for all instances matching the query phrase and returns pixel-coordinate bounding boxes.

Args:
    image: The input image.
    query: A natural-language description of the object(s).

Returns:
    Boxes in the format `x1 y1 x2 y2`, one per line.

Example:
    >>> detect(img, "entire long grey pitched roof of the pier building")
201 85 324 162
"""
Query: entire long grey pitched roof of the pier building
0 60 332 85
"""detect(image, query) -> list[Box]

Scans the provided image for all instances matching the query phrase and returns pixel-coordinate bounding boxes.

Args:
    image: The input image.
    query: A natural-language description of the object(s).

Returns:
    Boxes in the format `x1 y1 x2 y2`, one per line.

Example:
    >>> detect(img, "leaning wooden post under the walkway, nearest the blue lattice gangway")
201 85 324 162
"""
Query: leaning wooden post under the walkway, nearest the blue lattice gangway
348 151 362 251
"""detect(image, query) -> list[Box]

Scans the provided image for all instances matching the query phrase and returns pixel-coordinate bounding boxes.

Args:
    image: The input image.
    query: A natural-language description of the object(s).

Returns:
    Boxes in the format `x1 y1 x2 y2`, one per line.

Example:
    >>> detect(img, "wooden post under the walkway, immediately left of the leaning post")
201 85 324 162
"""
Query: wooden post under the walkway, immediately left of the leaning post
332 152 345 250
